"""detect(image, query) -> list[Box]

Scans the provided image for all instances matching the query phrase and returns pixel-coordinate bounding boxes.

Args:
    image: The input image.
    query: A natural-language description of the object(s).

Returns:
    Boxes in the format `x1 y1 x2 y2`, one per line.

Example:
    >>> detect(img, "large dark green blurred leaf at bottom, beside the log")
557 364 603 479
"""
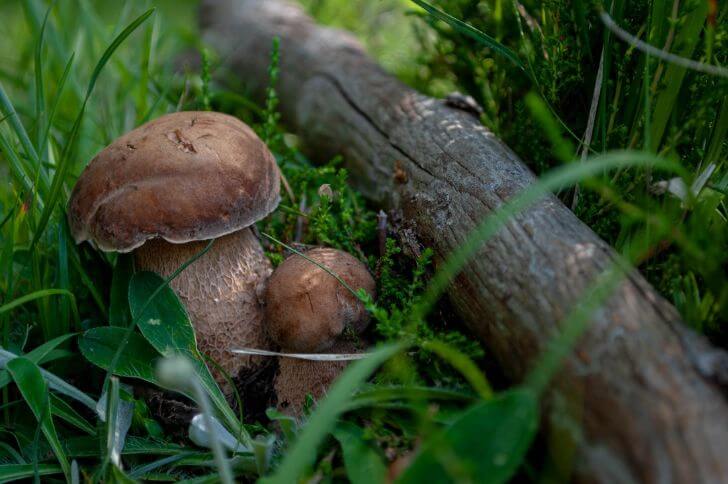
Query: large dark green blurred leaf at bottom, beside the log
397 389 538 484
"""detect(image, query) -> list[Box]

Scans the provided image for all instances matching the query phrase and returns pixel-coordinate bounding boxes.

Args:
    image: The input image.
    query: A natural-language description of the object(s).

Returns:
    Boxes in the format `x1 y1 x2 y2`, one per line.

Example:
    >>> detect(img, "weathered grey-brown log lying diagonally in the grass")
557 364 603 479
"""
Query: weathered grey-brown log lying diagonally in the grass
201 0 728 482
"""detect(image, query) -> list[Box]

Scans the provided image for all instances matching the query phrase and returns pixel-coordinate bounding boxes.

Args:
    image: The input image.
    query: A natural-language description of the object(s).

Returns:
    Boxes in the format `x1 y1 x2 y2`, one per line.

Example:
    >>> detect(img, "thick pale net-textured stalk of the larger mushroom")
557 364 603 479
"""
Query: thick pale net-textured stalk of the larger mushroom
134 229 272 391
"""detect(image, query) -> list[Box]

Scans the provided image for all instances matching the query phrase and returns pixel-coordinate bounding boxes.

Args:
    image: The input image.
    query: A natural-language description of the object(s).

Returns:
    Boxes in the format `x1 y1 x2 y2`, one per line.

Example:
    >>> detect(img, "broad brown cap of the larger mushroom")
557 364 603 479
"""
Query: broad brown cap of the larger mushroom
68 112 280 252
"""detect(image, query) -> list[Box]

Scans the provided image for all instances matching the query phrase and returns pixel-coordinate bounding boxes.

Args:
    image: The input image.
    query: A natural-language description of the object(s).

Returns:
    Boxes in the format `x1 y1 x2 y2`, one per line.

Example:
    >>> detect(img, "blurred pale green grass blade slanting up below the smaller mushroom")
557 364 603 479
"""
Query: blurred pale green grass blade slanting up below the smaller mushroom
260 344 405 484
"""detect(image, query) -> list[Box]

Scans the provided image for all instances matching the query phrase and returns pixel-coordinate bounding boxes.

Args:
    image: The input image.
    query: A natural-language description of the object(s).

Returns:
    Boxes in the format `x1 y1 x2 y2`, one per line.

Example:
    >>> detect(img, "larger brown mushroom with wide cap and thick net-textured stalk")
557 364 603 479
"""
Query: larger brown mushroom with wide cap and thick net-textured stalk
68 112 280 389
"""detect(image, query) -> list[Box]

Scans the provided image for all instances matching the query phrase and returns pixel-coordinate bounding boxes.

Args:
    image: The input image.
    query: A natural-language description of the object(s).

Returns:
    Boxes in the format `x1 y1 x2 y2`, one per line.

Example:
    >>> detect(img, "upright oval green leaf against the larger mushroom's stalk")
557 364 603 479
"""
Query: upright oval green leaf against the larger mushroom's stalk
129 272 243 434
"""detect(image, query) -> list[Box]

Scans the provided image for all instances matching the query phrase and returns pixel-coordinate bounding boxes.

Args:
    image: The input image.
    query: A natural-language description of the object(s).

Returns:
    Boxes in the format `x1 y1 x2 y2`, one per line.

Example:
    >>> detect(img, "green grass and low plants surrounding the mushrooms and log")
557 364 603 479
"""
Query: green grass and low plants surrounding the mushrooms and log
0 0 728 482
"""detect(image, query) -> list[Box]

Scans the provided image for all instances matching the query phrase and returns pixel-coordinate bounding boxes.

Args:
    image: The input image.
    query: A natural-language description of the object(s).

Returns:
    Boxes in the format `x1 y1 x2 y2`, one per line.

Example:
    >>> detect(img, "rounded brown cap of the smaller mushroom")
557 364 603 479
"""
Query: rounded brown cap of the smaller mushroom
265 248 376 352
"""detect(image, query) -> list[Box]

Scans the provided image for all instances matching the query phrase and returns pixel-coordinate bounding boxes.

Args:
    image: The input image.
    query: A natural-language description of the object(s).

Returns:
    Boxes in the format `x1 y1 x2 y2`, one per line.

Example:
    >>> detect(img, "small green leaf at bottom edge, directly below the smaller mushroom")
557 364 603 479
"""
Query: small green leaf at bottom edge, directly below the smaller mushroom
333 422 387 484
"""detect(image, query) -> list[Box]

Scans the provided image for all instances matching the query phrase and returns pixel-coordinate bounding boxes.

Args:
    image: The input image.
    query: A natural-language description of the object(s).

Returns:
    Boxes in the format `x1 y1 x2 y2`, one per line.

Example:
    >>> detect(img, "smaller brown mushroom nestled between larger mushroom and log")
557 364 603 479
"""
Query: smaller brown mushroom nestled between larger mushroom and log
265 248 376 414
